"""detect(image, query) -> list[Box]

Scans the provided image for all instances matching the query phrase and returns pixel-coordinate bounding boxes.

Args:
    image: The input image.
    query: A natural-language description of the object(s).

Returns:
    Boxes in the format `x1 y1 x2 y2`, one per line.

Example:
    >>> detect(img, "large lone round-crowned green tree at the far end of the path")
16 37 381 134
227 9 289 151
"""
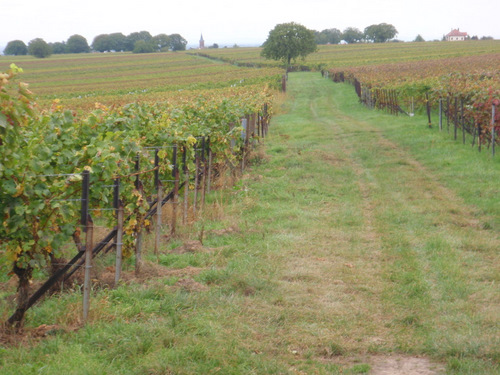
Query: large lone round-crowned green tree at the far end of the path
261 22 318 67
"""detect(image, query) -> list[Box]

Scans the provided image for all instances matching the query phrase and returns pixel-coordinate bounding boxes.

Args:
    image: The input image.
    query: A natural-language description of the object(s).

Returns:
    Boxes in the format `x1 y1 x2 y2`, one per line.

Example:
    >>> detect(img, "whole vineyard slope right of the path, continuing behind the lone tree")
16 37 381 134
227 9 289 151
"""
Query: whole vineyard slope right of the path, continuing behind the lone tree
194 40 500 152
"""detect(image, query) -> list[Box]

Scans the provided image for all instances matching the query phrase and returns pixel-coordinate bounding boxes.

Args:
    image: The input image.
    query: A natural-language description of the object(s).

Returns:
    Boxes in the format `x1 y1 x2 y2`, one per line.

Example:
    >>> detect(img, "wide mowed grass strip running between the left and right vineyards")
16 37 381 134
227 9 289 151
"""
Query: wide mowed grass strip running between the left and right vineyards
0 73 500 374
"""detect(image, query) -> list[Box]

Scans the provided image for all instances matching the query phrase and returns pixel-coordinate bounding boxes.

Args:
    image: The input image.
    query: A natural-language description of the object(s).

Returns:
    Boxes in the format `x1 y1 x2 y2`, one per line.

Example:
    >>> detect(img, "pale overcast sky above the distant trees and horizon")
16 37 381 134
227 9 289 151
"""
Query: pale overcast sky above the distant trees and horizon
0 0 500 50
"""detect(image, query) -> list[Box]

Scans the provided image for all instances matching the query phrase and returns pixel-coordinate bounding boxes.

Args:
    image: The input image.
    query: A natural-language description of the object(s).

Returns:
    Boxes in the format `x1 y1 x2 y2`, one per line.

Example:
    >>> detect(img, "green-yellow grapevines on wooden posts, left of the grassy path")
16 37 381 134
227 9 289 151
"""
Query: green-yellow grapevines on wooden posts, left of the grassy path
0 56 281 326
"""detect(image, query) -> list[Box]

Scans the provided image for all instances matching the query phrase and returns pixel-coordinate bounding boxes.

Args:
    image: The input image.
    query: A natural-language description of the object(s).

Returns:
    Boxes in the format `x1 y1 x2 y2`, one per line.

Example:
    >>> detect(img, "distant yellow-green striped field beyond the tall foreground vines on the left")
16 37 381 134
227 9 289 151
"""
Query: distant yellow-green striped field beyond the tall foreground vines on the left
0 53 282 110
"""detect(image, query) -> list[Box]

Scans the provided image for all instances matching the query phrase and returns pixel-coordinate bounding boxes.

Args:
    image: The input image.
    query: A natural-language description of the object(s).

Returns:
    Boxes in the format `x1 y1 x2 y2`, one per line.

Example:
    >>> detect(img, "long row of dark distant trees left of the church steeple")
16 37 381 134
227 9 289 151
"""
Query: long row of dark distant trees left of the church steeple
4 31 187 58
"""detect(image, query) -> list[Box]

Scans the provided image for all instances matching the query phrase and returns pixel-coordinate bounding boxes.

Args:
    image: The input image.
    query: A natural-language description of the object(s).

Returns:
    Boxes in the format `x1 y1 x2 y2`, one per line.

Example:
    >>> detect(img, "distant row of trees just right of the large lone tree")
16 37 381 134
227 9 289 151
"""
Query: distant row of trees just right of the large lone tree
314 23 398 44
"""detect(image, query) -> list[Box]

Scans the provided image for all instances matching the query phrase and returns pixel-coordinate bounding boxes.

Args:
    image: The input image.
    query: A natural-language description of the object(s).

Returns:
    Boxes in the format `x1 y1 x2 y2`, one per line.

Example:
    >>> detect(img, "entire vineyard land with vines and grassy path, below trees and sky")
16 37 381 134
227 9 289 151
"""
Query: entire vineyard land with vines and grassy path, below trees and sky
0 41 500 375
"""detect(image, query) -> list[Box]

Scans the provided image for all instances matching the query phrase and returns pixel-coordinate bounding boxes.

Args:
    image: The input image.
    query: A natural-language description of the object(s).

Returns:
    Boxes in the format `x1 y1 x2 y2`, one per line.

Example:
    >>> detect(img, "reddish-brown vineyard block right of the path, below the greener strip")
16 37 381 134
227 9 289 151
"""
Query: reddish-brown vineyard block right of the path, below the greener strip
326 53 500 150
